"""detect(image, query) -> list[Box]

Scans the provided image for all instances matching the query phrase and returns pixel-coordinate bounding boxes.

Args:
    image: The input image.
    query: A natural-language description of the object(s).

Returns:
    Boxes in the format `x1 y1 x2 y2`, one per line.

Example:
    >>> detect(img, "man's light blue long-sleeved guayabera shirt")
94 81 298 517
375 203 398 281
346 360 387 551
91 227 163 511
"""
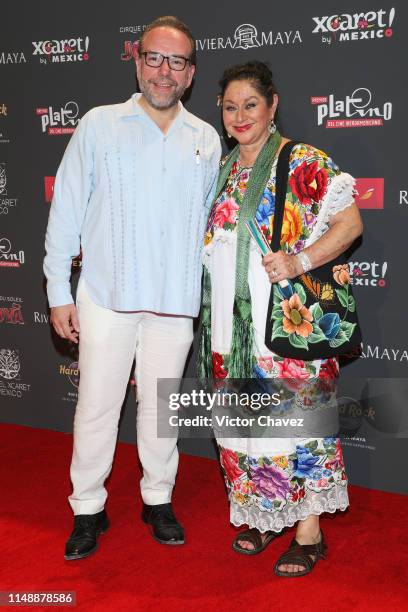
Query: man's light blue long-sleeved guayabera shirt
44 94 221 316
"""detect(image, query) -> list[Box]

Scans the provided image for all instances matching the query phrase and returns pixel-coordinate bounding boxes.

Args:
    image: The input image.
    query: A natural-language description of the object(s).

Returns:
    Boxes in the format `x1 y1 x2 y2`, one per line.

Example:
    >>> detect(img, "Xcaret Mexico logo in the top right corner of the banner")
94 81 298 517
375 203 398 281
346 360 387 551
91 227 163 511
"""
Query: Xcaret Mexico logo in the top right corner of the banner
312 8 395 44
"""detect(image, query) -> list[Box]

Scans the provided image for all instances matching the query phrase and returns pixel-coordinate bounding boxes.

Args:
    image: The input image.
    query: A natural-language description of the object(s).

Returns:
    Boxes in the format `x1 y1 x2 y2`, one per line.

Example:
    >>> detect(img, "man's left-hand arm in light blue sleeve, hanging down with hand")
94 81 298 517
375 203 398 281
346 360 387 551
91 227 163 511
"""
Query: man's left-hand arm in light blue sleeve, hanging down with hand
44 111 95 342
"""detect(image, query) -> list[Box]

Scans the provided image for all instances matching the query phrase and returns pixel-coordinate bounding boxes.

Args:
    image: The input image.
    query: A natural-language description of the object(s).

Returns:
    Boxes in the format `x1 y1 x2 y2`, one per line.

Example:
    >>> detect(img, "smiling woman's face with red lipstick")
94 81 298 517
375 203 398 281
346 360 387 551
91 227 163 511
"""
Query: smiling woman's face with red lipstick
222 80 278 146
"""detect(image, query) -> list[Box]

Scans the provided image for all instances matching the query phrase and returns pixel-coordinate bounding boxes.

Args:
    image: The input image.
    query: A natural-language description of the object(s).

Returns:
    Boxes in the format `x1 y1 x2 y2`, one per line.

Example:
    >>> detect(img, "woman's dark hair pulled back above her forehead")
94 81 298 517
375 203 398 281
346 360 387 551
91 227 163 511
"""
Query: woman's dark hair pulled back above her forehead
219 61 278 106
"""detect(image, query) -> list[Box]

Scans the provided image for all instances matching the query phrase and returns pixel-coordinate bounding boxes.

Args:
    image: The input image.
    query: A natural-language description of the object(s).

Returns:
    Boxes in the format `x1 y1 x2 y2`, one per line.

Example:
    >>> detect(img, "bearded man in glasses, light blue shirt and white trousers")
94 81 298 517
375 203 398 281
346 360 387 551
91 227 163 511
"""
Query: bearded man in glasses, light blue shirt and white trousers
44 17 221 560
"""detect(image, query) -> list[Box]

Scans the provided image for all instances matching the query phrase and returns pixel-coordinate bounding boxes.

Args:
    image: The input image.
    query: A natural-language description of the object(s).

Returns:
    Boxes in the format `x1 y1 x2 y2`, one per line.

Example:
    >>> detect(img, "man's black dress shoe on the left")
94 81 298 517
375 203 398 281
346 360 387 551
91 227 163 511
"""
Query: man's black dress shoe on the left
64 510 109 561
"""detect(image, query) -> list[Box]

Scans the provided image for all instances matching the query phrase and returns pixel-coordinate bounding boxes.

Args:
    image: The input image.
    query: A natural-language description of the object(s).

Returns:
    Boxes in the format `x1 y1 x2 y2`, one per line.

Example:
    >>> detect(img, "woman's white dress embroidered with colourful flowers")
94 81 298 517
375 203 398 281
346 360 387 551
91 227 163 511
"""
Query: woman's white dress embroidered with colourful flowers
203 144 354 532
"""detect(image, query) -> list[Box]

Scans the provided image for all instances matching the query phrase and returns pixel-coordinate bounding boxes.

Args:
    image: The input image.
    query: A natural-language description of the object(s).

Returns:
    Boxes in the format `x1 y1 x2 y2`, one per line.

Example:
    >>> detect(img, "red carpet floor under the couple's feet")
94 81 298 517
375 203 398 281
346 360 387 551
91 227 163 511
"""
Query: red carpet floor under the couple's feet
0 425 408 612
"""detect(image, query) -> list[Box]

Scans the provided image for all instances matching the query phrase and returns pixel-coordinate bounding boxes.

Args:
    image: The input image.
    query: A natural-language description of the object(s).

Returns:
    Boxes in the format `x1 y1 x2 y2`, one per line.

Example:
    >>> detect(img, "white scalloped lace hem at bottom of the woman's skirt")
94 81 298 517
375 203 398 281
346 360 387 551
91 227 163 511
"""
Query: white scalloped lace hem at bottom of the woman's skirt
230 485 350 533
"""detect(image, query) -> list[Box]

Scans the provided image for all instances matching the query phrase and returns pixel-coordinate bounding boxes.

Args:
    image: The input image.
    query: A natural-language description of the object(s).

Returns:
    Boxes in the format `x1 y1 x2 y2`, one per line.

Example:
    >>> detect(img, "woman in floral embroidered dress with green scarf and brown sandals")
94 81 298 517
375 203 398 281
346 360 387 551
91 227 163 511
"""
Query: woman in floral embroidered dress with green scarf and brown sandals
200 62 362 577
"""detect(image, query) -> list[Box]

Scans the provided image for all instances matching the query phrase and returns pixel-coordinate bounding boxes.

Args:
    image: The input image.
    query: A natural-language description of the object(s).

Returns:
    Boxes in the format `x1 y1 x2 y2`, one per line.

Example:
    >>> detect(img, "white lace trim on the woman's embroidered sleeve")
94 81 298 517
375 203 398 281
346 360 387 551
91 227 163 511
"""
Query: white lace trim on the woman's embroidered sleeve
305 172 356 246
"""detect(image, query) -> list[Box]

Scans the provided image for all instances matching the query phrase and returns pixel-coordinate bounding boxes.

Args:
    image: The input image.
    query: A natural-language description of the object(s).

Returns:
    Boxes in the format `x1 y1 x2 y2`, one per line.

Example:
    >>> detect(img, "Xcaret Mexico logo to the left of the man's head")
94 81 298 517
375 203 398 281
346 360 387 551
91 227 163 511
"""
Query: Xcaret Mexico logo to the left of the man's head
33 36 89 64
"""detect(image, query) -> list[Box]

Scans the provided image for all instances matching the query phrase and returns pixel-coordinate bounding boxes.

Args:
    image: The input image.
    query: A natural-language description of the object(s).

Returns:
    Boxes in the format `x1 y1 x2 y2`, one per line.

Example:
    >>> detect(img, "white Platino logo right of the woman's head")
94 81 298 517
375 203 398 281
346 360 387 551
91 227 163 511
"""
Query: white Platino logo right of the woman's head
310 87 392 128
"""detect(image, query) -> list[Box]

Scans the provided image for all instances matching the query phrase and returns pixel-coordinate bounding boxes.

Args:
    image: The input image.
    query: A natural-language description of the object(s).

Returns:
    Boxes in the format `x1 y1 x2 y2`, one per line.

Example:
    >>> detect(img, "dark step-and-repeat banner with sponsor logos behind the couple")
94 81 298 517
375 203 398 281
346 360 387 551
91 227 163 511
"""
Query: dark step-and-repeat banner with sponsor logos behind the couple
0 0 408 492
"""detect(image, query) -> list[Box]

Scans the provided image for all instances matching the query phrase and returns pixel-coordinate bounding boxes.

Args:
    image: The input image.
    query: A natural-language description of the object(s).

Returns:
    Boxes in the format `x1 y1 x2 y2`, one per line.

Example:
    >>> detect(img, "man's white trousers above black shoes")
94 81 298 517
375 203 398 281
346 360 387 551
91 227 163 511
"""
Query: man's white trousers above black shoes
68 279 193 514
